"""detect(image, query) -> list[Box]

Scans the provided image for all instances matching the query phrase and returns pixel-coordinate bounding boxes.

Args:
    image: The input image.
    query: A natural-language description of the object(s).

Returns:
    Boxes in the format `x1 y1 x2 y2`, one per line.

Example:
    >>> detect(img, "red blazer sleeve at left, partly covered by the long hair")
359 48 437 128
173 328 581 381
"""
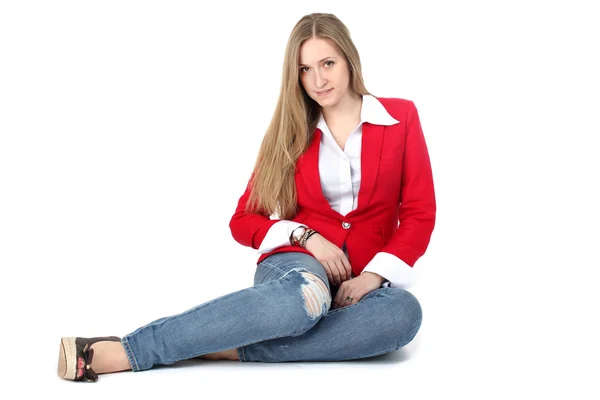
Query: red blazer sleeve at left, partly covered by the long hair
229 173 279 250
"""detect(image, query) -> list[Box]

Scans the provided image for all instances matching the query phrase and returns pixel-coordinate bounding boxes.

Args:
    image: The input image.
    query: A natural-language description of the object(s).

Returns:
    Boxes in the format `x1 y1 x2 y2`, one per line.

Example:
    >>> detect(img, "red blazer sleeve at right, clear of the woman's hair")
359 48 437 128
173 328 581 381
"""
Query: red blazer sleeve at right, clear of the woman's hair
381 101 436 267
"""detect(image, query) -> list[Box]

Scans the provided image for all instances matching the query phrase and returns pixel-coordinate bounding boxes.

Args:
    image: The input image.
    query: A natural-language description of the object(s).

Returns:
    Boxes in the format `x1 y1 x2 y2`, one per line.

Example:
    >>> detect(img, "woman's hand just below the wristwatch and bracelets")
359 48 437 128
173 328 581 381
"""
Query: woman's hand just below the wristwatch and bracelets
305 233 352 286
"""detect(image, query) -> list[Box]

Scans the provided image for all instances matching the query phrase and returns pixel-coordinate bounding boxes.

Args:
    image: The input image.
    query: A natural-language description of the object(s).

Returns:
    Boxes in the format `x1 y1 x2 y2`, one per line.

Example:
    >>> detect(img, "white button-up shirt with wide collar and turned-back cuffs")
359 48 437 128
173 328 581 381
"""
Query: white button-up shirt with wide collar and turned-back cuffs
258 95 415 289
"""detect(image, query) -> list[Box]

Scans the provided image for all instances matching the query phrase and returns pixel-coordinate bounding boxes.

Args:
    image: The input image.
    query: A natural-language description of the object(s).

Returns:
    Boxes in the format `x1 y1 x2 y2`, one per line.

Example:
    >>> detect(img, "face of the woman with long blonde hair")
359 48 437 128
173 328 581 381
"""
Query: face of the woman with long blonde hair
298 38 350 107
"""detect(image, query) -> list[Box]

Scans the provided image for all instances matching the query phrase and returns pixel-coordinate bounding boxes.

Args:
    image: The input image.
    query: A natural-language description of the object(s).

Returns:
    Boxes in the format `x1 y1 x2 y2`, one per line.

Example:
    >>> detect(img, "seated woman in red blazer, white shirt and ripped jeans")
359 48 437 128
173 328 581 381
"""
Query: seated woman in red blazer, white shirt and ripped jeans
58 14 436 382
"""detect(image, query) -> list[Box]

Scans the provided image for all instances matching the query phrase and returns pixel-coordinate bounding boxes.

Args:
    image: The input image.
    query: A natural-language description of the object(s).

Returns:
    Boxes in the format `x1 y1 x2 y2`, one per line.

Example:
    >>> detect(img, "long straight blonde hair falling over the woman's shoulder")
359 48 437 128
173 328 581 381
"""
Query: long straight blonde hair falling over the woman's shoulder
246 13 369 219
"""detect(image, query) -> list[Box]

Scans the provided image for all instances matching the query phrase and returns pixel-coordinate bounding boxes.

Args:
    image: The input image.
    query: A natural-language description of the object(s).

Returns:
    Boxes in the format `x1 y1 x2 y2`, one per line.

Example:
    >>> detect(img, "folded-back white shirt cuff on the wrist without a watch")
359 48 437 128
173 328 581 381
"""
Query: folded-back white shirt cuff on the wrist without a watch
361 252 416 289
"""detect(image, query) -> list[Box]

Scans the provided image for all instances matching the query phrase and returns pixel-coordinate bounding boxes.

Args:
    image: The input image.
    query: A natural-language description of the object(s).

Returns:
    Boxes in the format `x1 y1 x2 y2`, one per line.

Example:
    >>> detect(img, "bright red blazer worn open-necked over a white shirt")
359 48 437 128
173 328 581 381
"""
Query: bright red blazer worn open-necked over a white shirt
229 97 436 276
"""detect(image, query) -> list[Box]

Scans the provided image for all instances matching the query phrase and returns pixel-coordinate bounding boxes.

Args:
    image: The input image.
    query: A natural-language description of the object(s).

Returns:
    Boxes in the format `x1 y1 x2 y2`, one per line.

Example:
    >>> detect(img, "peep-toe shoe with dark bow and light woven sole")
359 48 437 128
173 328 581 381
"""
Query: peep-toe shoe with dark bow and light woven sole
58 336 121 382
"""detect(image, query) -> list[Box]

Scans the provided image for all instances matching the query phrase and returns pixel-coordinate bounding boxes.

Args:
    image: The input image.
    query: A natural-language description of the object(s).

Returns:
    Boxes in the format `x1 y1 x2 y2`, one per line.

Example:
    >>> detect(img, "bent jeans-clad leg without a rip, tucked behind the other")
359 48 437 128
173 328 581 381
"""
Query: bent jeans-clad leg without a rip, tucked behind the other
238 287 422 362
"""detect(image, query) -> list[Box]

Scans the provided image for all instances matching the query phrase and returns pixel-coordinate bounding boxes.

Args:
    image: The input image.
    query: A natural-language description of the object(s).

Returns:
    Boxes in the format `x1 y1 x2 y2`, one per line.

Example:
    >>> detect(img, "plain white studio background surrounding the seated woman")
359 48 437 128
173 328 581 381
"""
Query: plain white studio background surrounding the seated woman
0 0 600 399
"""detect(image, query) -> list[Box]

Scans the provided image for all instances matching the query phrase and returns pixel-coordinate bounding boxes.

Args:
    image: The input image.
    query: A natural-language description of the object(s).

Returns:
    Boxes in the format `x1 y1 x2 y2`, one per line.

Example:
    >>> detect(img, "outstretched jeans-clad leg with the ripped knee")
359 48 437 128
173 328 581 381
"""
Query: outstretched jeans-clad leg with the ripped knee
121 252 331 371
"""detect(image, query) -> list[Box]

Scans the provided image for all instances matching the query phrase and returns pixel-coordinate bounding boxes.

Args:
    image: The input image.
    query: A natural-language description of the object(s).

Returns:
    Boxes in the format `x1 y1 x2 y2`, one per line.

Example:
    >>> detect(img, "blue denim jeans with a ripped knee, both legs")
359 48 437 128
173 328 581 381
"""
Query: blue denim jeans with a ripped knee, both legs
121 252 422 371
